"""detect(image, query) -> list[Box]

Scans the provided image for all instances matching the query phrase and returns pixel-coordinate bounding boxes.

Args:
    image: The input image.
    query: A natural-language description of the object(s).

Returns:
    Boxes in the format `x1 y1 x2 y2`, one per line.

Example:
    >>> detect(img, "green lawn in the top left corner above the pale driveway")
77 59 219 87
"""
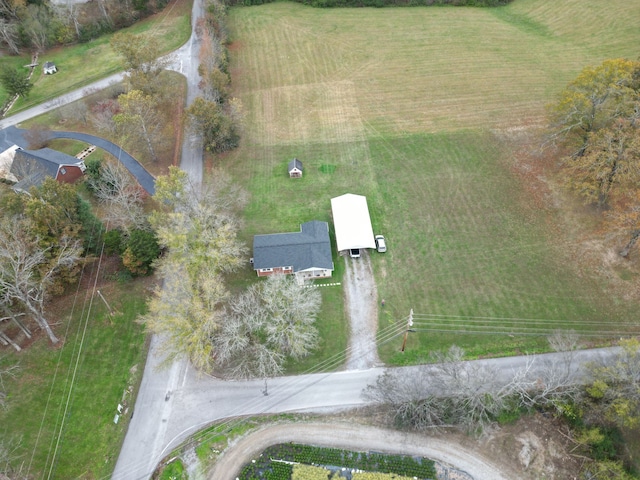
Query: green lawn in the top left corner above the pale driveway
0 0 193 114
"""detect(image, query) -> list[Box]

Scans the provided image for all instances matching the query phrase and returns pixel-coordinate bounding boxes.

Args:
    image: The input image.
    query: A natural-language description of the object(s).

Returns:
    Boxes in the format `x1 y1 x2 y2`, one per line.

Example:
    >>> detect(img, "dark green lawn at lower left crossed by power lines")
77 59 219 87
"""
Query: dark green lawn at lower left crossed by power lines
0 265 146 478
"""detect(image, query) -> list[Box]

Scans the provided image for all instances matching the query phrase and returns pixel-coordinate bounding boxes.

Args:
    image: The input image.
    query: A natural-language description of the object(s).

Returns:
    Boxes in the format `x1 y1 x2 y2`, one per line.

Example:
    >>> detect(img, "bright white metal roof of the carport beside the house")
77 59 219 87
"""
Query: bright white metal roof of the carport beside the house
331 193 376 251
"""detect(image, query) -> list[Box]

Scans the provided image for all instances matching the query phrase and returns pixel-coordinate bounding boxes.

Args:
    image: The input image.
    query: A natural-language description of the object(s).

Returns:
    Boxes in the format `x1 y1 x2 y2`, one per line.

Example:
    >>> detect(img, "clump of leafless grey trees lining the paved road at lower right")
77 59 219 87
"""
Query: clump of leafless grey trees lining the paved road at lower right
364 344 579 431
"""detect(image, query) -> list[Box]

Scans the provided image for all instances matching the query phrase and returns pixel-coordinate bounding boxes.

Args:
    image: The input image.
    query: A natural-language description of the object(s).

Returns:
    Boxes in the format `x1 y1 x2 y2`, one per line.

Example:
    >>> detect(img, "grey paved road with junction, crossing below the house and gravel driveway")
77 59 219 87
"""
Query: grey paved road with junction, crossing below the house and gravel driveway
114 349 616 479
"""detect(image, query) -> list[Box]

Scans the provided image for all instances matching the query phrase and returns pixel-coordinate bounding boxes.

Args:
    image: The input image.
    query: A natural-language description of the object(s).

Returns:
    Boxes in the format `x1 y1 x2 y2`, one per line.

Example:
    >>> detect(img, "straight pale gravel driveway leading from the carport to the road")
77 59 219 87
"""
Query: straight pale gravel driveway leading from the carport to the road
344 250 380 370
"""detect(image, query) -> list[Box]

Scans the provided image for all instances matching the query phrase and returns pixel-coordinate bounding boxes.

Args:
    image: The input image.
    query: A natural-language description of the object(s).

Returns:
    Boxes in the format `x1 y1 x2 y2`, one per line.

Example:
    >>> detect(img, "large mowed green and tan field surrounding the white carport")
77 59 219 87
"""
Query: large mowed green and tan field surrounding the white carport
226 0 640 363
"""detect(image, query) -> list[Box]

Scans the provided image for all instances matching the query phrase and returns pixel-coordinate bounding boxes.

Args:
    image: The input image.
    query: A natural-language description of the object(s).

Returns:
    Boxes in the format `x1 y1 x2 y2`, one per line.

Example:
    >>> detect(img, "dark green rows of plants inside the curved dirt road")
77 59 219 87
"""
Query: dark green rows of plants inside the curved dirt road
239 443 436 480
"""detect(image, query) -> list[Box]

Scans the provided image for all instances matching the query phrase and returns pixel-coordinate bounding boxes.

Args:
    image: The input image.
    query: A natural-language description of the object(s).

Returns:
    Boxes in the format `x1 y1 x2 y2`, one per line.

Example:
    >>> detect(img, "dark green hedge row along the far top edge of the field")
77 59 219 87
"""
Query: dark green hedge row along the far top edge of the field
227 0 513 8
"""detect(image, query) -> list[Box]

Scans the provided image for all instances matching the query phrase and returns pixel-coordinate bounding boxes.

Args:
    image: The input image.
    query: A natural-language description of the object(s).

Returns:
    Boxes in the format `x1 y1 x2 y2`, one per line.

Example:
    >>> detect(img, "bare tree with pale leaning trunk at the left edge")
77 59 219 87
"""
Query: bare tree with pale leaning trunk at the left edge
0 222 82 343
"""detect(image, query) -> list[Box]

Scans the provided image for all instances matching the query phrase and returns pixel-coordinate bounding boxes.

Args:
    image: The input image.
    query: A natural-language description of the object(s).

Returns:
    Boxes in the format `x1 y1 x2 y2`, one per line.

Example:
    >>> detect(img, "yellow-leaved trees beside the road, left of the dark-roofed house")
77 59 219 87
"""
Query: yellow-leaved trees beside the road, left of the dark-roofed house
142 167 245 371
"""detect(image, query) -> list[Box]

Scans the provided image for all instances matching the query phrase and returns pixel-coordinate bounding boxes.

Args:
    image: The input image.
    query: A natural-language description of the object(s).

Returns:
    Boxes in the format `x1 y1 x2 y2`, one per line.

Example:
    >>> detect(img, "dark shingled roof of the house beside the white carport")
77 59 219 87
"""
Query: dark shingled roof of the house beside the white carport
253 220 333 272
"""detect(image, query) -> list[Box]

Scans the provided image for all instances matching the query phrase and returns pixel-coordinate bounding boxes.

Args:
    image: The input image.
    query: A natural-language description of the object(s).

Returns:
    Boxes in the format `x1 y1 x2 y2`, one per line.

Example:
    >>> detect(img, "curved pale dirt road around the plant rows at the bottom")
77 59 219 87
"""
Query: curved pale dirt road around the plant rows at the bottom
208 422 518 480
